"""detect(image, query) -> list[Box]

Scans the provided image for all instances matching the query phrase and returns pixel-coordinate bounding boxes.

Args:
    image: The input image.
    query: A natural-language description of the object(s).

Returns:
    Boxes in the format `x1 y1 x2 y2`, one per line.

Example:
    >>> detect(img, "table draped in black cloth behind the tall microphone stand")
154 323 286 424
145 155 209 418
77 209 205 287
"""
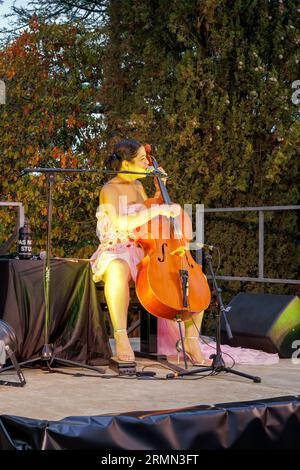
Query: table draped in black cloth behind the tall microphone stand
0 258 111 365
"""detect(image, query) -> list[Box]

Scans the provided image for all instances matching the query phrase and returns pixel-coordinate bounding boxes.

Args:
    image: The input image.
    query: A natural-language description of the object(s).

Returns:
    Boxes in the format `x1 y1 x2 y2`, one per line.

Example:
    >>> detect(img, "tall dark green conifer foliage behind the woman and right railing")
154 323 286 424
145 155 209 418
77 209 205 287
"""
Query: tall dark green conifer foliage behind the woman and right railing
99 0 300 298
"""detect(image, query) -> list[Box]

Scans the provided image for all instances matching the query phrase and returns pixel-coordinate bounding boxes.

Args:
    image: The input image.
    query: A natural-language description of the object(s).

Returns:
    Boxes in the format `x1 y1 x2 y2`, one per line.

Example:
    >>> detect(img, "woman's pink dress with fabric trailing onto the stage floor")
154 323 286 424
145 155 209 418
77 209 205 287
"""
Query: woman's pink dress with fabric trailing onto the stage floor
91 204 279 365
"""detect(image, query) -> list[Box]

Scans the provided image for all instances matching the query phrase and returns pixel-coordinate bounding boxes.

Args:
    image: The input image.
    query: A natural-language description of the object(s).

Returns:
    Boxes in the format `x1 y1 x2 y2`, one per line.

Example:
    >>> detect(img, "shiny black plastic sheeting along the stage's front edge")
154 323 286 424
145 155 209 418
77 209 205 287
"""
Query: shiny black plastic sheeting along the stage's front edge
0 396 300 452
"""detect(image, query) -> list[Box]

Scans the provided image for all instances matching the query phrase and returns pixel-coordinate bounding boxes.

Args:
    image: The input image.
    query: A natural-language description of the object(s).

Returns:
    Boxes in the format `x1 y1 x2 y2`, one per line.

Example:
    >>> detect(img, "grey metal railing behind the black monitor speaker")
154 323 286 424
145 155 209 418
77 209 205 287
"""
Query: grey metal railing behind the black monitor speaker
196 206 300 284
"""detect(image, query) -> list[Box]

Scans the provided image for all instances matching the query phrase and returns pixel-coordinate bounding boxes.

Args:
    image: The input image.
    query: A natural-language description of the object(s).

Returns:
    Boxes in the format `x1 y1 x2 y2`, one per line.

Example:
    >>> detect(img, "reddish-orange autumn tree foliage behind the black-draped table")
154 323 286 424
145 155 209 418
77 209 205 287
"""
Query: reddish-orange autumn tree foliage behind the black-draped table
0 20 103 256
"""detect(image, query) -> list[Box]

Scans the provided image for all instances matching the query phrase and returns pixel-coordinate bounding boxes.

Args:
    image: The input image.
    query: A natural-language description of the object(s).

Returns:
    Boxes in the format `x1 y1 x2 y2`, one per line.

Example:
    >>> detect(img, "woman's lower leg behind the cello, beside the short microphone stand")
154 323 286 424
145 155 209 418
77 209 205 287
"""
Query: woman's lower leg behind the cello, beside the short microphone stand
184 310 211 365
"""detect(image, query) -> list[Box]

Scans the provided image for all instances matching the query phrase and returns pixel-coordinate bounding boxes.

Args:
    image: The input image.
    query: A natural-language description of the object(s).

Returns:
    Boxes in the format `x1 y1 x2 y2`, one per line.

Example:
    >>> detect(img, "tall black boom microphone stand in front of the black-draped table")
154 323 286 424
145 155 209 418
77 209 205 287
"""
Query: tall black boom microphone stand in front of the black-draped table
0 167 165 374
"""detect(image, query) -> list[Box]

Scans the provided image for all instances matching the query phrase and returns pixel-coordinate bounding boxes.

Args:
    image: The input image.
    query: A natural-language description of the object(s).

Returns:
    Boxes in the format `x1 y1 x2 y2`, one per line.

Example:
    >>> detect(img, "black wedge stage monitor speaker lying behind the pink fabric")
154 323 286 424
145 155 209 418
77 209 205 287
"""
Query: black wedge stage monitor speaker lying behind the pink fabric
221 293 300 358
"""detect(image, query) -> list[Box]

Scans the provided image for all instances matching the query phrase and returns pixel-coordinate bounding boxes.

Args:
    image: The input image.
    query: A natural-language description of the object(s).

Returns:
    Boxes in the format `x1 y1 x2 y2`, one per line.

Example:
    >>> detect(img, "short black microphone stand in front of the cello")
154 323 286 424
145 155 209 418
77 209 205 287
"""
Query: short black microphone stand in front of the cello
166 246 261 383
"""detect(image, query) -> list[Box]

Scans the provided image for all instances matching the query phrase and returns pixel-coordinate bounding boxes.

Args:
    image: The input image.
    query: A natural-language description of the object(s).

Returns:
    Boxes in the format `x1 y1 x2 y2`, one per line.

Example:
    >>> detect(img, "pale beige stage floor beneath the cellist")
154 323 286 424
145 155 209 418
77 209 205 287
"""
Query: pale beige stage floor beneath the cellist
0 344 300 421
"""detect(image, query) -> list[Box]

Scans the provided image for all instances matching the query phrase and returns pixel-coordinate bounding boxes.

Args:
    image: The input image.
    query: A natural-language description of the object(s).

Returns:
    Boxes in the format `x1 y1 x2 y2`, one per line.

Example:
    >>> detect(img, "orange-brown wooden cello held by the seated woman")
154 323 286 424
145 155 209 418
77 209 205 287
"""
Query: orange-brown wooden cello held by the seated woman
136 144 211 321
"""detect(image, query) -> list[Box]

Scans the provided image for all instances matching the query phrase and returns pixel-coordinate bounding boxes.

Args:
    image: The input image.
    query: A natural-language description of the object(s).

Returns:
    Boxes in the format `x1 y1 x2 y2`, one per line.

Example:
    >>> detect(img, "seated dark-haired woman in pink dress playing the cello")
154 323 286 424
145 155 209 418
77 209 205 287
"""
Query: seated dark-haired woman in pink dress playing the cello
91 140 211 365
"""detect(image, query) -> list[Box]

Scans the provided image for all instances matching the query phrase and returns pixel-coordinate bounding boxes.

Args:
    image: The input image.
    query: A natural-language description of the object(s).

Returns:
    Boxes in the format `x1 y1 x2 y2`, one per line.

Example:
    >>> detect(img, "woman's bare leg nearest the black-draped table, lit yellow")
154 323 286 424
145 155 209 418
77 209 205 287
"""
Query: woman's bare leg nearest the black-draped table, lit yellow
103 259 134 361
